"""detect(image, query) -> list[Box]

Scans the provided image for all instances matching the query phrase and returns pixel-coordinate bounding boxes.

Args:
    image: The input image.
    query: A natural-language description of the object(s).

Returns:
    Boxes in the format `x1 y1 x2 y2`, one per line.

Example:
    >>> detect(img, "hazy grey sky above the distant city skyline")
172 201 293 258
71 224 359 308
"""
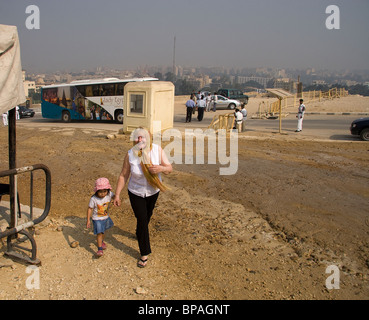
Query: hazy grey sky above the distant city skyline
0 0 369 72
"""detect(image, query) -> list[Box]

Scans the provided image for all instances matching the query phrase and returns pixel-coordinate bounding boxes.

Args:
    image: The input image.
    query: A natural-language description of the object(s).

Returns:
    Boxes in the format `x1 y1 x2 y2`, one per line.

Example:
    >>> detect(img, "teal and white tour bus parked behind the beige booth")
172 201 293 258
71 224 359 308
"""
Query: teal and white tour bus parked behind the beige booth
41 78 158 123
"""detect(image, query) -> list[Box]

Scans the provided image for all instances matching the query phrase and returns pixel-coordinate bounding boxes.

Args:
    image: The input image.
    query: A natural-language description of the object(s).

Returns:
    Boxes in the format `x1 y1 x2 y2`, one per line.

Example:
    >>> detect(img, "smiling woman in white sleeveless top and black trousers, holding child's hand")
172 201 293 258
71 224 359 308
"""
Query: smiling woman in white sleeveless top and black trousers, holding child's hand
114 128 172 268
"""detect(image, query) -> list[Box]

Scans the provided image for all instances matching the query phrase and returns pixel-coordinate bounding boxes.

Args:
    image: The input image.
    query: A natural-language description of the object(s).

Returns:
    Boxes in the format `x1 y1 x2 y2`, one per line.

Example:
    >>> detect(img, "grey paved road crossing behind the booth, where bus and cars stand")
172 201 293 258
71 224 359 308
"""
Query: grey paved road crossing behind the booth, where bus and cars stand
12 111 363 141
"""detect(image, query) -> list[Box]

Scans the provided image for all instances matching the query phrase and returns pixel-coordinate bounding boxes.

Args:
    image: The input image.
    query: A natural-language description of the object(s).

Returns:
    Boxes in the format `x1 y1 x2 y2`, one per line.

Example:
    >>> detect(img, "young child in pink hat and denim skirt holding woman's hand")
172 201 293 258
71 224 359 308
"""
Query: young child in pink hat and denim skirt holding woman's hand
86 178 114 257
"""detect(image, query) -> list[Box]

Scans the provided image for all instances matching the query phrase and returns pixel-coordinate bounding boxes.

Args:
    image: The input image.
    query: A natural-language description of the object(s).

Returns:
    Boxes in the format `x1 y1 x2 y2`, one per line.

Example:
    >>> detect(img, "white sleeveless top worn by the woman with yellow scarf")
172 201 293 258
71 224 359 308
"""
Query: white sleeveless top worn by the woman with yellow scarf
128 143 161 198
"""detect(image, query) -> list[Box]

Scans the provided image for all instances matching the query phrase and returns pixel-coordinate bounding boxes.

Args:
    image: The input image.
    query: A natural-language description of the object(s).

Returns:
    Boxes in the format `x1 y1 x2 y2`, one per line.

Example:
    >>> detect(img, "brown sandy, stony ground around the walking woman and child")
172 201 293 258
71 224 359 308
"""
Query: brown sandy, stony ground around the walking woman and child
0 96 369 300
